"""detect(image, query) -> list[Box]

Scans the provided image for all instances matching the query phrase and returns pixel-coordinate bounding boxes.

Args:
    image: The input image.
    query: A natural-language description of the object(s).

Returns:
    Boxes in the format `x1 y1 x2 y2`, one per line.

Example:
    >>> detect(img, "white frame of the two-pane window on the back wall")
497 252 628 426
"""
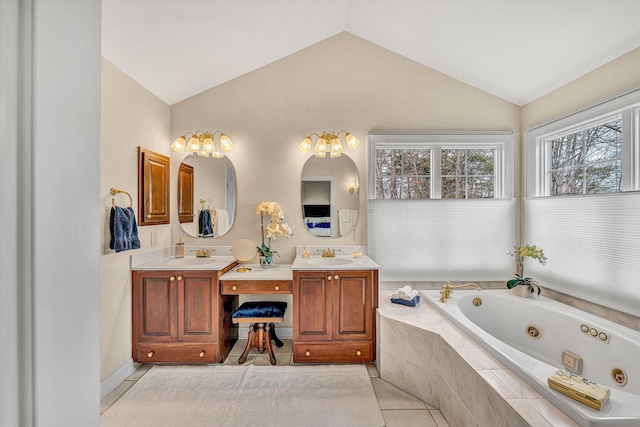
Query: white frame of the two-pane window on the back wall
367 131 514 200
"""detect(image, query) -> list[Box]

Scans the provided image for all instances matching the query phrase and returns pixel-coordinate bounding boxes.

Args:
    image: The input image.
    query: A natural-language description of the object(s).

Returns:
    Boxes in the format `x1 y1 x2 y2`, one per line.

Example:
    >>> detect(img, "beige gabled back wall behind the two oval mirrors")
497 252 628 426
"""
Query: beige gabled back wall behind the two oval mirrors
171 33 519 263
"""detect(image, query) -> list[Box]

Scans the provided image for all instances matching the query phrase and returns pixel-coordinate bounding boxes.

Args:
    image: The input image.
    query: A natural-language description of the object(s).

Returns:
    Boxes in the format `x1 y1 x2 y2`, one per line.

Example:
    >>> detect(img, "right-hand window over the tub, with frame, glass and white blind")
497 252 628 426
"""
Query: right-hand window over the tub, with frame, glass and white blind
522 88 640 316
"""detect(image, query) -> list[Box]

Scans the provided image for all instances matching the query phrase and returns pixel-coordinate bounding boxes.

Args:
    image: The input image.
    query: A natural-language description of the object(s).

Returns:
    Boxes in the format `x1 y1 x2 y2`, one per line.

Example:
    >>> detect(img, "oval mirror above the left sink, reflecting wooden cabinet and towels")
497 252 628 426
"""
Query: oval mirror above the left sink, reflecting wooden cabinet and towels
178 154 236 238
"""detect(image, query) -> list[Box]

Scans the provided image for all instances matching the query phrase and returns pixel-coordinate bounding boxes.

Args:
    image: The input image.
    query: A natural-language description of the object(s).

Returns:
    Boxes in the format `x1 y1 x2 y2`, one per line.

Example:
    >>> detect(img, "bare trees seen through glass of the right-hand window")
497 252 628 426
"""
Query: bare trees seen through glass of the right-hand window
550 118 622 196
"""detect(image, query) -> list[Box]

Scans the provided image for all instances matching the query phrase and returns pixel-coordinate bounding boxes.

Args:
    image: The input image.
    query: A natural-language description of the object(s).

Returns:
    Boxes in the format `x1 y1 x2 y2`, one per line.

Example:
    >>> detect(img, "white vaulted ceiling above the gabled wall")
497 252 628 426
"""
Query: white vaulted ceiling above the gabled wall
102 0 640 105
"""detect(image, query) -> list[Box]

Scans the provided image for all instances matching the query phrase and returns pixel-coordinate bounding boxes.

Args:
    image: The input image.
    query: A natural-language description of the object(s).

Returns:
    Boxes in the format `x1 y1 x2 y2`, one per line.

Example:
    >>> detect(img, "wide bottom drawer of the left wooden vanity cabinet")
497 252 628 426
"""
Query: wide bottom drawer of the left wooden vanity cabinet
135 343 220 363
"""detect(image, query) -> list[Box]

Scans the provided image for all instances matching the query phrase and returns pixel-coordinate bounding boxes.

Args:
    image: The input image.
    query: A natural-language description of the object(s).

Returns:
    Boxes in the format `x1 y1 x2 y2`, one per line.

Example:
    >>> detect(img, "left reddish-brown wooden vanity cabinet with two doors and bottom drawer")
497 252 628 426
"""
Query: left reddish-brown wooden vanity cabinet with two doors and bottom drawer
132 270 237 363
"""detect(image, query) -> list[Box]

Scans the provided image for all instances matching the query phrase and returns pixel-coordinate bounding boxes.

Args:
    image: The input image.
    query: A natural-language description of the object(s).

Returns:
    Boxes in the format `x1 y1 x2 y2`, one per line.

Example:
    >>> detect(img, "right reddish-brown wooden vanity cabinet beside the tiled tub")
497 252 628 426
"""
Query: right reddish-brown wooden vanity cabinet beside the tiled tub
293 270 378 363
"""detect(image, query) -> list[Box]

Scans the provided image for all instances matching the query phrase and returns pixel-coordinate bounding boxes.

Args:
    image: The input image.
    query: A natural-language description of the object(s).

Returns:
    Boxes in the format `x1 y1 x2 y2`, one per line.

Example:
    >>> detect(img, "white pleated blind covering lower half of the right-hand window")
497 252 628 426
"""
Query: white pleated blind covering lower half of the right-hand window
523 192 640 316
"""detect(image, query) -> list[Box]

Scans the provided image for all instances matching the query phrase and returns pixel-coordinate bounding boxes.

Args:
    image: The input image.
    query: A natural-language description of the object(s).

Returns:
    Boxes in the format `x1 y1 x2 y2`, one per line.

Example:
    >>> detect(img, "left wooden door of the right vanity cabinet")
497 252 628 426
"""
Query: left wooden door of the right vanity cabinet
293 271 333 341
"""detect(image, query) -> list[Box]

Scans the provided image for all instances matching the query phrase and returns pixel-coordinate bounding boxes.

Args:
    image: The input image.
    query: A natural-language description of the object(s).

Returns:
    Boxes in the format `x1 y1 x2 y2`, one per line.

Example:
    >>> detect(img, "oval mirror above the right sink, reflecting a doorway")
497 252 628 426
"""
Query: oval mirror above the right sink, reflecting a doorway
302 154 360 238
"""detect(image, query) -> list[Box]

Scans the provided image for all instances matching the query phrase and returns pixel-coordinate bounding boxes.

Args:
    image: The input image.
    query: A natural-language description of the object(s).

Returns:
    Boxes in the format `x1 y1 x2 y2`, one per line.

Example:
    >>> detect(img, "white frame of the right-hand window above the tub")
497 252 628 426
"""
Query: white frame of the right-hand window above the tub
524 88 640 197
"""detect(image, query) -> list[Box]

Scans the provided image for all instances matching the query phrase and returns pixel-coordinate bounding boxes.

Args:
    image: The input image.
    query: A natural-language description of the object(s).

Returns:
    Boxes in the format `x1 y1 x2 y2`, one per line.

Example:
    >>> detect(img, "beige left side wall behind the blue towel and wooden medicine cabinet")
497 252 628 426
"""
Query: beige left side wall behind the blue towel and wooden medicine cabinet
100 59 171 380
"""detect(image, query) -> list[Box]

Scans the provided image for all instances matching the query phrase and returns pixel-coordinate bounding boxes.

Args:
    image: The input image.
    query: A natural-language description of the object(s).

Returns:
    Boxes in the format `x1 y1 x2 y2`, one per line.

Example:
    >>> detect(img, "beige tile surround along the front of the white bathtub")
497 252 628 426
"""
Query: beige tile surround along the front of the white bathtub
376 290 577 427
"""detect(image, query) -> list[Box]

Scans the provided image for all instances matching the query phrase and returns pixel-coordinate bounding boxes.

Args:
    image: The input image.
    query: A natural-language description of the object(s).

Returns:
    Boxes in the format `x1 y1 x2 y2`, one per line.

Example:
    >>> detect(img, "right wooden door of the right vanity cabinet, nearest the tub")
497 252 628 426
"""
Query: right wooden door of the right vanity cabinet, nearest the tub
333 270 375 341
